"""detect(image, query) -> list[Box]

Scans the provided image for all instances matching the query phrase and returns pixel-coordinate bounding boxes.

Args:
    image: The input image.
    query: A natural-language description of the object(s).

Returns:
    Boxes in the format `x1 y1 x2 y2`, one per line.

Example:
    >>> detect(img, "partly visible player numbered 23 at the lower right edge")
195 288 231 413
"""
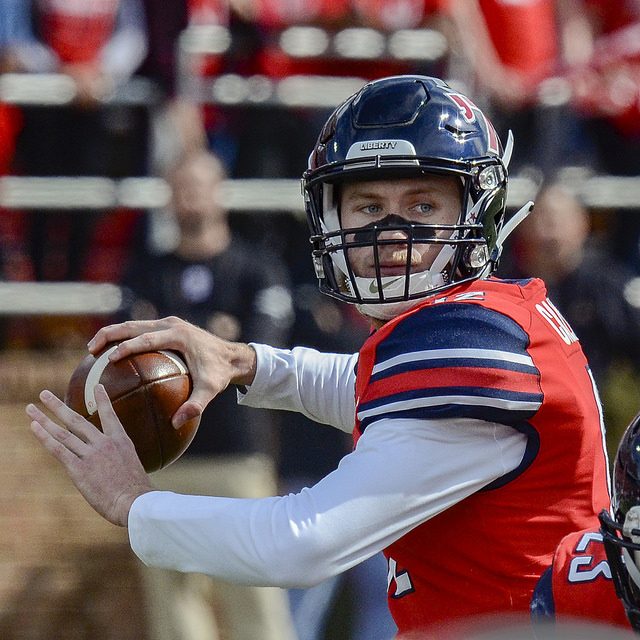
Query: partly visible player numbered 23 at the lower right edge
531 414 640 631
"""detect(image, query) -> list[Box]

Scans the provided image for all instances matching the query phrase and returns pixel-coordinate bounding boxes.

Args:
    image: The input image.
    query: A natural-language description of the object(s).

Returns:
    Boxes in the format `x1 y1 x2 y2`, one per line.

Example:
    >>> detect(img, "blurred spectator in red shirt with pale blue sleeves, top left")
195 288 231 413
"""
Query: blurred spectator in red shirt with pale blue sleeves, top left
8 0 147 280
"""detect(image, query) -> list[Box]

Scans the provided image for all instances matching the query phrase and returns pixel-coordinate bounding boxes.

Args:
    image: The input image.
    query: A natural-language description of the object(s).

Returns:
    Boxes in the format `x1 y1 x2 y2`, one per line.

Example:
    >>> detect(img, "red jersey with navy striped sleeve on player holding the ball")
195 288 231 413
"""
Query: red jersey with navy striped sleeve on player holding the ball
354 278 609 632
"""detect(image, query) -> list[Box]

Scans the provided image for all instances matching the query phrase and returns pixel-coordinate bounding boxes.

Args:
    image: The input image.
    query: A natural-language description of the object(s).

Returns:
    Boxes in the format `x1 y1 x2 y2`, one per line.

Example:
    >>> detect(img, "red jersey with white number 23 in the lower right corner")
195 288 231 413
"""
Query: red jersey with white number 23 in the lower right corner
551 530 631 629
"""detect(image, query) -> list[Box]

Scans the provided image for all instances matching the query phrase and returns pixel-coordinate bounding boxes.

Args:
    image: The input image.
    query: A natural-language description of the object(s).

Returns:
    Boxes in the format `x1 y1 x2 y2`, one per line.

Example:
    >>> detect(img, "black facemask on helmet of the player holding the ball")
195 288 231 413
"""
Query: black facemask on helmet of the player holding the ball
307 164 505 318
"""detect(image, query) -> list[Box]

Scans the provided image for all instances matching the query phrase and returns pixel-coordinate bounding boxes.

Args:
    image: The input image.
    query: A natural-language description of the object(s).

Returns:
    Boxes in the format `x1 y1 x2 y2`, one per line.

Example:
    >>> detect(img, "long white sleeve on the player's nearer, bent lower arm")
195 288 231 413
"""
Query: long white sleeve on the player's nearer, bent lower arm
129 419 526 587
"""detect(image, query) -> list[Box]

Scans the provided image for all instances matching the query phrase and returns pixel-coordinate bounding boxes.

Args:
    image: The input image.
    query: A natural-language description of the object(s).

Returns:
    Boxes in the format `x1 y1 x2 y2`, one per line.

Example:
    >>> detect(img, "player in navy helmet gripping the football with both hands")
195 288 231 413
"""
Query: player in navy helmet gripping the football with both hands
27 76 609 633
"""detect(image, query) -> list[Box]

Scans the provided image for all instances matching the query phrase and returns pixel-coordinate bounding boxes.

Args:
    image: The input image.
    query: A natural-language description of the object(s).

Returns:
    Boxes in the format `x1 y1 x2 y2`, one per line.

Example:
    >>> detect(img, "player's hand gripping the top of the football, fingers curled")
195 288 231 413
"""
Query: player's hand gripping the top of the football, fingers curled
87 316 256 428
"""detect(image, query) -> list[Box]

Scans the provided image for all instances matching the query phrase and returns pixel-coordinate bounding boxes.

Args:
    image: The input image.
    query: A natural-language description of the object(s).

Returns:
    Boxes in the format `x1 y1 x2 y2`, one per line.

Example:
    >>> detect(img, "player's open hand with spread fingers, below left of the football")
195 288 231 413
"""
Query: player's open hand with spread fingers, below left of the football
26 385 152 527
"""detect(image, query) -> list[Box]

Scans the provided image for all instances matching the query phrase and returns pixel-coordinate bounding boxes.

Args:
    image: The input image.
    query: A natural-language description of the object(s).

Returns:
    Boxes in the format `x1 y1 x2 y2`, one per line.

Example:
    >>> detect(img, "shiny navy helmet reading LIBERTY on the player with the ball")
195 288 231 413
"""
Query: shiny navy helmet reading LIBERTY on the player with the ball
302 75 532 317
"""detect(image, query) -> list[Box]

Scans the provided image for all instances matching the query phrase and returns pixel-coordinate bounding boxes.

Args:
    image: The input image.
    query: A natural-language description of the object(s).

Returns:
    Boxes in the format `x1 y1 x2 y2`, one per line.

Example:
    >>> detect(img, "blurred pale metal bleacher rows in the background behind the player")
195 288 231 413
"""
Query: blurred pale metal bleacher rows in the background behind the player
0 26 640 316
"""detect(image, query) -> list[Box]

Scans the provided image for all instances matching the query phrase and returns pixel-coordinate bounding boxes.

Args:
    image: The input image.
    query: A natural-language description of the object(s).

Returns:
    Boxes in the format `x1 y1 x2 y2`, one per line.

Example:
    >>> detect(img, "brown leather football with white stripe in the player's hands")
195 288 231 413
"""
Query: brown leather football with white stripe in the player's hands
64 345 200 473
